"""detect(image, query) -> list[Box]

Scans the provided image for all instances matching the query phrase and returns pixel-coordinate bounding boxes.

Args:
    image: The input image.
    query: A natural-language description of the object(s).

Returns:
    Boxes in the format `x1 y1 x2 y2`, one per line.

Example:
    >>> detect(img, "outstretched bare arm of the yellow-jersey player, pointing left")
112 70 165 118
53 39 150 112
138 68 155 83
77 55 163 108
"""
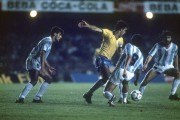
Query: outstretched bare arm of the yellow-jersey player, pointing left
78 20 102 33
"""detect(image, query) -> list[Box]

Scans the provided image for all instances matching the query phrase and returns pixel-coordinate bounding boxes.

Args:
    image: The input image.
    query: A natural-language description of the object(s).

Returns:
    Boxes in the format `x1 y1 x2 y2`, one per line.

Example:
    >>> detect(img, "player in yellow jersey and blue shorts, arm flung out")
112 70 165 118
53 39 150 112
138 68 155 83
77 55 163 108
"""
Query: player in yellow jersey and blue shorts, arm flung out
78 20 127 104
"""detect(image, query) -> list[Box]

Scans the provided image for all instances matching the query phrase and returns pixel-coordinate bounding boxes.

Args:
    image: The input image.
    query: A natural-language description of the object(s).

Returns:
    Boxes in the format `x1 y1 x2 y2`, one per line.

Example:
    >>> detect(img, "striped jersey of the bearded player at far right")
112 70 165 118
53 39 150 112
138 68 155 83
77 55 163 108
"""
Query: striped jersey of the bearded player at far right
149 43 178 66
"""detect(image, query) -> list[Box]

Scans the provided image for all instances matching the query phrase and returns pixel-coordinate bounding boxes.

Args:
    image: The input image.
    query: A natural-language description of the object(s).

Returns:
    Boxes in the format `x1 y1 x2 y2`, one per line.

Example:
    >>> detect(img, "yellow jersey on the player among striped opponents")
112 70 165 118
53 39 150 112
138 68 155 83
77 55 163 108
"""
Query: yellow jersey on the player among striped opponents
99 29 124 60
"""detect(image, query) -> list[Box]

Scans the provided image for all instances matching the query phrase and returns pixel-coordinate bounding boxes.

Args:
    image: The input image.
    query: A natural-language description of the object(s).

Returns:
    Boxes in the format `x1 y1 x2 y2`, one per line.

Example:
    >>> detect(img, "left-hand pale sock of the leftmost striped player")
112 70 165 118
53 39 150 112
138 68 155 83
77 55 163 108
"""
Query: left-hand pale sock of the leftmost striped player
19 83 33 98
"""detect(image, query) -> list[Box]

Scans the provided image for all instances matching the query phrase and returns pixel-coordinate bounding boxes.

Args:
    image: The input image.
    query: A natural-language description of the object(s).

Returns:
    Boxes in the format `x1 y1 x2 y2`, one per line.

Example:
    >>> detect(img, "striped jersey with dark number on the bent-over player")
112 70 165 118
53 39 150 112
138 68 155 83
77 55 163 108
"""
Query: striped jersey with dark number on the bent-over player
118 43 144 73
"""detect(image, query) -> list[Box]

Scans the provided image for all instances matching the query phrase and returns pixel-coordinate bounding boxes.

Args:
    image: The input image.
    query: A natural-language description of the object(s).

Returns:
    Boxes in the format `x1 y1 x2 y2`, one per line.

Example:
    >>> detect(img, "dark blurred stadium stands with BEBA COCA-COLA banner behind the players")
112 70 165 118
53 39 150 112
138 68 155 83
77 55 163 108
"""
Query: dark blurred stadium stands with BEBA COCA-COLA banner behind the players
0 0 180 84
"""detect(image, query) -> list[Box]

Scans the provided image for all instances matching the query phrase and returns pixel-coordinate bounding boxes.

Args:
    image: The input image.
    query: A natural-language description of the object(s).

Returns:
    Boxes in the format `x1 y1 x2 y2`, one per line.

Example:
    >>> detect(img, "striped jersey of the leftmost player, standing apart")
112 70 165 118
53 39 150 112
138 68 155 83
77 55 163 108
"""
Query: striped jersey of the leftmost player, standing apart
26 36 52 70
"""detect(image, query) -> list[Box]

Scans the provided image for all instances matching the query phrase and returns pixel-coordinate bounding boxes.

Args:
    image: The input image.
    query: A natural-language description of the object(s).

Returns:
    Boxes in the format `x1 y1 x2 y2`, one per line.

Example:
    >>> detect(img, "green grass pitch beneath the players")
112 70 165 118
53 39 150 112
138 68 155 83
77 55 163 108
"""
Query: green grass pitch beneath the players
0 83 180 120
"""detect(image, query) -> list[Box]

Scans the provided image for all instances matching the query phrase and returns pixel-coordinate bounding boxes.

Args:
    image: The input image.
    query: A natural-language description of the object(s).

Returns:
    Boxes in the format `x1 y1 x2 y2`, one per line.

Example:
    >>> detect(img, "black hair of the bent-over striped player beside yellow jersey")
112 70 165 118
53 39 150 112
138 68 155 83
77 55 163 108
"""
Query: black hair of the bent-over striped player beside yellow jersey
131 34 142 47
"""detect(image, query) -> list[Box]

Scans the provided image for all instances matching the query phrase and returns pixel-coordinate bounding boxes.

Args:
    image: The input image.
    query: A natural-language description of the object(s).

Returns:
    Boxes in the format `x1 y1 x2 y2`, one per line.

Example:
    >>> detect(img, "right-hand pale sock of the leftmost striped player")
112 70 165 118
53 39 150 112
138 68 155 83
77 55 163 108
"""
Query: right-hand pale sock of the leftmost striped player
34 82 49 100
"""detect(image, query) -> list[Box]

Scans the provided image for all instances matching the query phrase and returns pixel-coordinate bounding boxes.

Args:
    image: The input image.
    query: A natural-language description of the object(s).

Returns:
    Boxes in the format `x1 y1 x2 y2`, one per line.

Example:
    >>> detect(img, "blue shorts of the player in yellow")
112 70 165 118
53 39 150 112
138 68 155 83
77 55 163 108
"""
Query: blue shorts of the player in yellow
94 55 113 71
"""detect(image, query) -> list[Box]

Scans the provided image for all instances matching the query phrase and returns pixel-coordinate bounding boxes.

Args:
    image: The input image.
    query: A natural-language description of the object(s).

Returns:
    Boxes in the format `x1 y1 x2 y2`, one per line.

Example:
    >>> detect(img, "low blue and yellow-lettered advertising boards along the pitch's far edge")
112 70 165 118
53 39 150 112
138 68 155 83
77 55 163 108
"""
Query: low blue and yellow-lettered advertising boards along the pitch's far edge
0 73 173 84
